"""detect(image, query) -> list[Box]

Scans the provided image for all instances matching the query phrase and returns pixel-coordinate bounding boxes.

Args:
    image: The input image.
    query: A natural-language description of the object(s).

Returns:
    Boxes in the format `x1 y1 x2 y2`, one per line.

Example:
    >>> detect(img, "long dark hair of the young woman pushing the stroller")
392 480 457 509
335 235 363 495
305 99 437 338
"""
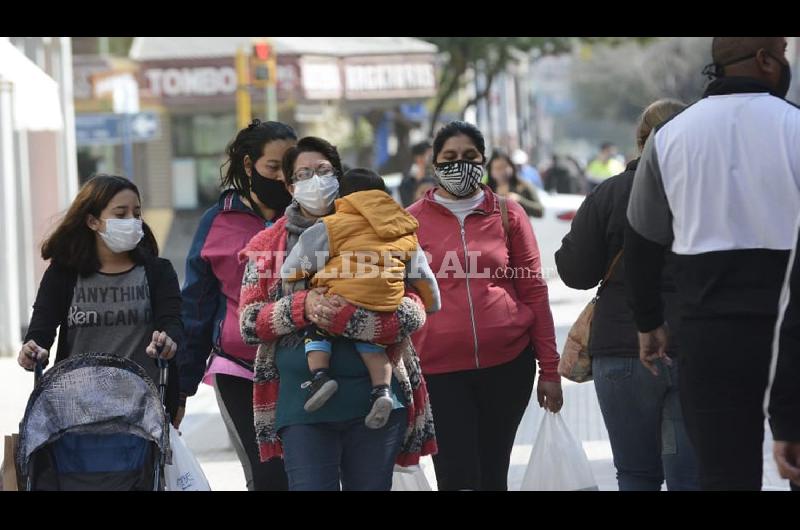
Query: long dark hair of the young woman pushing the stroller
42 175 158 275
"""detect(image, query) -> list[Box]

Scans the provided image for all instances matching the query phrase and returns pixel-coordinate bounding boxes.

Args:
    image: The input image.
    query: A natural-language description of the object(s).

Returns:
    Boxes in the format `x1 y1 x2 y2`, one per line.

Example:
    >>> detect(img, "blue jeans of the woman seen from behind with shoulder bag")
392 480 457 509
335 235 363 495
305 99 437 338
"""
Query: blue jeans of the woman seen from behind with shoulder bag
592 356 699 491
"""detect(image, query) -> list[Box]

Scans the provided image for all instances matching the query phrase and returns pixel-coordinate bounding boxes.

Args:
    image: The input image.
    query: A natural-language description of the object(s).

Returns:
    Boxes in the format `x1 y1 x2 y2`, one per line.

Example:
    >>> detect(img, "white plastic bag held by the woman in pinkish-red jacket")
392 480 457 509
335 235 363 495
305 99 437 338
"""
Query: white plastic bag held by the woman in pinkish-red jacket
520 412 598 491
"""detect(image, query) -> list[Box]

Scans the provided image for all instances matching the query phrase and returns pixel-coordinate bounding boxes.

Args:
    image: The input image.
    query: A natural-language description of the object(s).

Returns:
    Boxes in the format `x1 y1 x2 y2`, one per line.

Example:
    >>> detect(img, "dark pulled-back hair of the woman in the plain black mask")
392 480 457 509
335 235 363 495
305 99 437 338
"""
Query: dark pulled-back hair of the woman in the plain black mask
219 119 297 198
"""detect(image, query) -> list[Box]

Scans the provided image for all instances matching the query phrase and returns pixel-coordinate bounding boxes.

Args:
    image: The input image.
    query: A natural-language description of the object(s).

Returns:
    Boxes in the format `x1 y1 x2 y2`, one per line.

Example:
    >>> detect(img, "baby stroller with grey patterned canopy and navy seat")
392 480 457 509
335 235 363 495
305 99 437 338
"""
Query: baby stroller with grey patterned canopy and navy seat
17 354 169 491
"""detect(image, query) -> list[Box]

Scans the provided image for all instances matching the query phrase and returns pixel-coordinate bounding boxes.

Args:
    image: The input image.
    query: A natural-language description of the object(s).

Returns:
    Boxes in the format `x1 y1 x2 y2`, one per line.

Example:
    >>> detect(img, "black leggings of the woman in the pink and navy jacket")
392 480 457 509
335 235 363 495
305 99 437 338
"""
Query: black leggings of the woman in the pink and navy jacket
214 374 289 491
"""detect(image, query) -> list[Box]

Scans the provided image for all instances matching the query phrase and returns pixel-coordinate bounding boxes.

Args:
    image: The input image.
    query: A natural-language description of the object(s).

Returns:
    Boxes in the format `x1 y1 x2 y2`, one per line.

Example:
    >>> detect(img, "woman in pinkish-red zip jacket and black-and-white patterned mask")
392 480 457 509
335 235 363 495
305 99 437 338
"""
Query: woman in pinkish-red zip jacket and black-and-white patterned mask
408 121 563 490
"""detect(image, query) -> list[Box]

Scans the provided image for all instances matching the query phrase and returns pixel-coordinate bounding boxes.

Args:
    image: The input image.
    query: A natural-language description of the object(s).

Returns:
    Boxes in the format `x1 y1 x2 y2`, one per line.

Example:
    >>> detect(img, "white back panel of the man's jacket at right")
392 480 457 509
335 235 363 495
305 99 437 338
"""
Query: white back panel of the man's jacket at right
655 93 800 255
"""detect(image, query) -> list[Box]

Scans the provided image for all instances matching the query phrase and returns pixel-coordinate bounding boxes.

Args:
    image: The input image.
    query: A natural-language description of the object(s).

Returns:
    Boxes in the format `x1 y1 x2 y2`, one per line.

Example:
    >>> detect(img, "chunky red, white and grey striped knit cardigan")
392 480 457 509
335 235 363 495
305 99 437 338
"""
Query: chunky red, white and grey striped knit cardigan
239 217 437 466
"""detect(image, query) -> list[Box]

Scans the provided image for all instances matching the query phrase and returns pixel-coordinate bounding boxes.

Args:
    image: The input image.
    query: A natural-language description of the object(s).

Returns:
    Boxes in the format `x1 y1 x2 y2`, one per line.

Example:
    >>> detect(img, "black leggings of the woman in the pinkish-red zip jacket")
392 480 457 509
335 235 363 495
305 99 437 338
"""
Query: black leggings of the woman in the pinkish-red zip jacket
425 346 536 491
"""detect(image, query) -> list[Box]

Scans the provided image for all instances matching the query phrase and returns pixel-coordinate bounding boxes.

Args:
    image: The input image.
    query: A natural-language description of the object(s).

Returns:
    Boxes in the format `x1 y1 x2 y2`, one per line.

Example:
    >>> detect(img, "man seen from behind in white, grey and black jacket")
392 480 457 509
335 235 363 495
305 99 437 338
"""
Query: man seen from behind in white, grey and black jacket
625 37 800 490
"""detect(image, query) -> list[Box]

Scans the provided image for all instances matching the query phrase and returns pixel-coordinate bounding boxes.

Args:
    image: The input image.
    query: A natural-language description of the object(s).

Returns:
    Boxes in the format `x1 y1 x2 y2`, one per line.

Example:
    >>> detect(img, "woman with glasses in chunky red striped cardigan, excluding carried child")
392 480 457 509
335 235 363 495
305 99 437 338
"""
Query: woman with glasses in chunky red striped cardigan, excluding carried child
239 137 436 491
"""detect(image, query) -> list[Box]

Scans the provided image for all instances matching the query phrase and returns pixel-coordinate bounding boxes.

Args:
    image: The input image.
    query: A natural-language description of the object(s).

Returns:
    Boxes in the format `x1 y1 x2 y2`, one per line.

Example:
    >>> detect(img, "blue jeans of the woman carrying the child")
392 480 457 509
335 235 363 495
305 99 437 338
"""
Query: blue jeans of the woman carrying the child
280 408 407 491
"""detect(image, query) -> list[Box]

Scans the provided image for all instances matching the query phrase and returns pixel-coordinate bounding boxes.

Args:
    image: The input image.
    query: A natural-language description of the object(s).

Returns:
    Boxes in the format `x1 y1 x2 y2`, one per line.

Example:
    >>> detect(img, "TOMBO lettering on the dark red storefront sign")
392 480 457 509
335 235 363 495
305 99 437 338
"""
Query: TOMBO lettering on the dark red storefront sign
144 66 236 98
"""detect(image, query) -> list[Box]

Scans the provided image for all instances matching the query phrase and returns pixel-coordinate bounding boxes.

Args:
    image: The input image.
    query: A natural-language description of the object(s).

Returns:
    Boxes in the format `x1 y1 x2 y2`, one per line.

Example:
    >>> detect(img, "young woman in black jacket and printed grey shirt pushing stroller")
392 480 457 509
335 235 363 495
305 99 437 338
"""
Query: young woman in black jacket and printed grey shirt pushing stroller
18 175 183 418
